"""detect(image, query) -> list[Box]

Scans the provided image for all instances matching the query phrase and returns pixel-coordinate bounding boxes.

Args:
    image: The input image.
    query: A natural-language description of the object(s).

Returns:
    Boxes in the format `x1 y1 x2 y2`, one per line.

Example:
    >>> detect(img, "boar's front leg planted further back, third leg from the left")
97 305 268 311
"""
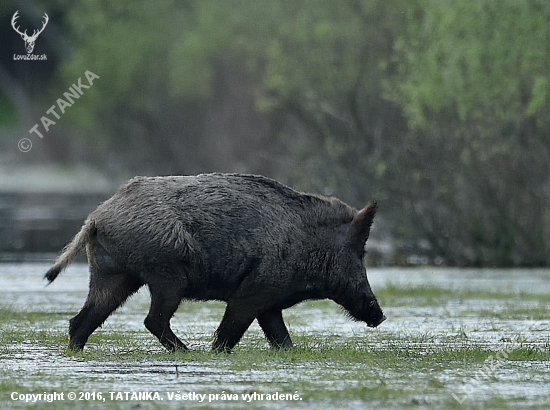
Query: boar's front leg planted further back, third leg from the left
212 301 257 353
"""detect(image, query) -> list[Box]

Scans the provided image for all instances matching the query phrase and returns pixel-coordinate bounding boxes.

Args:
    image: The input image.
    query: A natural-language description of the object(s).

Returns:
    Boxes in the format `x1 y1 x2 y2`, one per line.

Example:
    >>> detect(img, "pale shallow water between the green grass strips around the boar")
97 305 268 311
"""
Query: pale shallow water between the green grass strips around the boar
0 264 550 409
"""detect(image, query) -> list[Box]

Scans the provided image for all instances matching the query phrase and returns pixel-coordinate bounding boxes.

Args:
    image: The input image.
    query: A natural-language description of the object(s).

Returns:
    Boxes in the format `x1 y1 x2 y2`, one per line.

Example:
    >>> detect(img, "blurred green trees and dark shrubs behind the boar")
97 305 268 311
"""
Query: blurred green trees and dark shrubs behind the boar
0 0 550 266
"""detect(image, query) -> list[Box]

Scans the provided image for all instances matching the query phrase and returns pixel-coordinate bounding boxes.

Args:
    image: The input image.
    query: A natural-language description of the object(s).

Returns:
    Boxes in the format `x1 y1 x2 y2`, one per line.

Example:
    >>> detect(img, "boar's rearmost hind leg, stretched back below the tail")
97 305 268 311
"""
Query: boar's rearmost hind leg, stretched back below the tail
69 267 143 351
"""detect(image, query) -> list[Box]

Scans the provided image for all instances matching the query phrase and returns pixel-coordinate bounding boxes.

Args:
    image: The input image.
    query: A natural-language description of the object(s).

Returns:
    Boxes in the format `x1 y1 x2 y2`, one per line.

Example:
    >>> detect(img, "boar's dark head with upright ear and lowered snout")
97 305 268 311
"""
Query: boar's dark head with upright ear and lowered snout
334 202 386 327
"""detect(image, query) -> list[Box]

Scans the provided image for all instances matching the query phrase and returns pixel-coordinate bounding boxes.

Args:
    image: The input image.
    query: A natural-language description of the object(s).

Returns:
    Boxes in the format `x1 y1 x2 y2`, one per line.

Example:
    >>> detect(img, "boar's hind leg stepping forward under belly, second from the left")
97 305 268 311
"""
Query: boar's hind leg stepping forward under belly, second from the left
144 284 188 352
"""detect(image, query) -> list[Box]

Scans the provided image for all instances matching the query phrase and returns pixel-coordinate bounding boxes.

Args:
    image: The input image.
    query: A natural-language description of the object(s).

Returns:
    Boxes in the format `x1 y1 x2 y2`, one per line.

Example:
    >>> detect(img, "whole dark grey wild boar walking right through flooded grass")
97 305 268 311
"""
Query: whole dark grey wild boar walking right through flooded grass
45 174 386 352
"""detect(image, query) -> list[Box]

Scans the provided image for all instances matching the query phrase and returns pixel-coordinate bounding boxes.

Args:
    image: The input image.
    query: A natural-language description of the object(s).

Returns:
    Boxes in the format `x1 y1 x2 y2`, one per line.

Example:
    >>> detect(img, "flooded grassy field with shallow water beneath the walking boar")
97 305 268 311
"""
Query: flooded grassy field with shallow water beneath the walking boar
0 264 550 409
